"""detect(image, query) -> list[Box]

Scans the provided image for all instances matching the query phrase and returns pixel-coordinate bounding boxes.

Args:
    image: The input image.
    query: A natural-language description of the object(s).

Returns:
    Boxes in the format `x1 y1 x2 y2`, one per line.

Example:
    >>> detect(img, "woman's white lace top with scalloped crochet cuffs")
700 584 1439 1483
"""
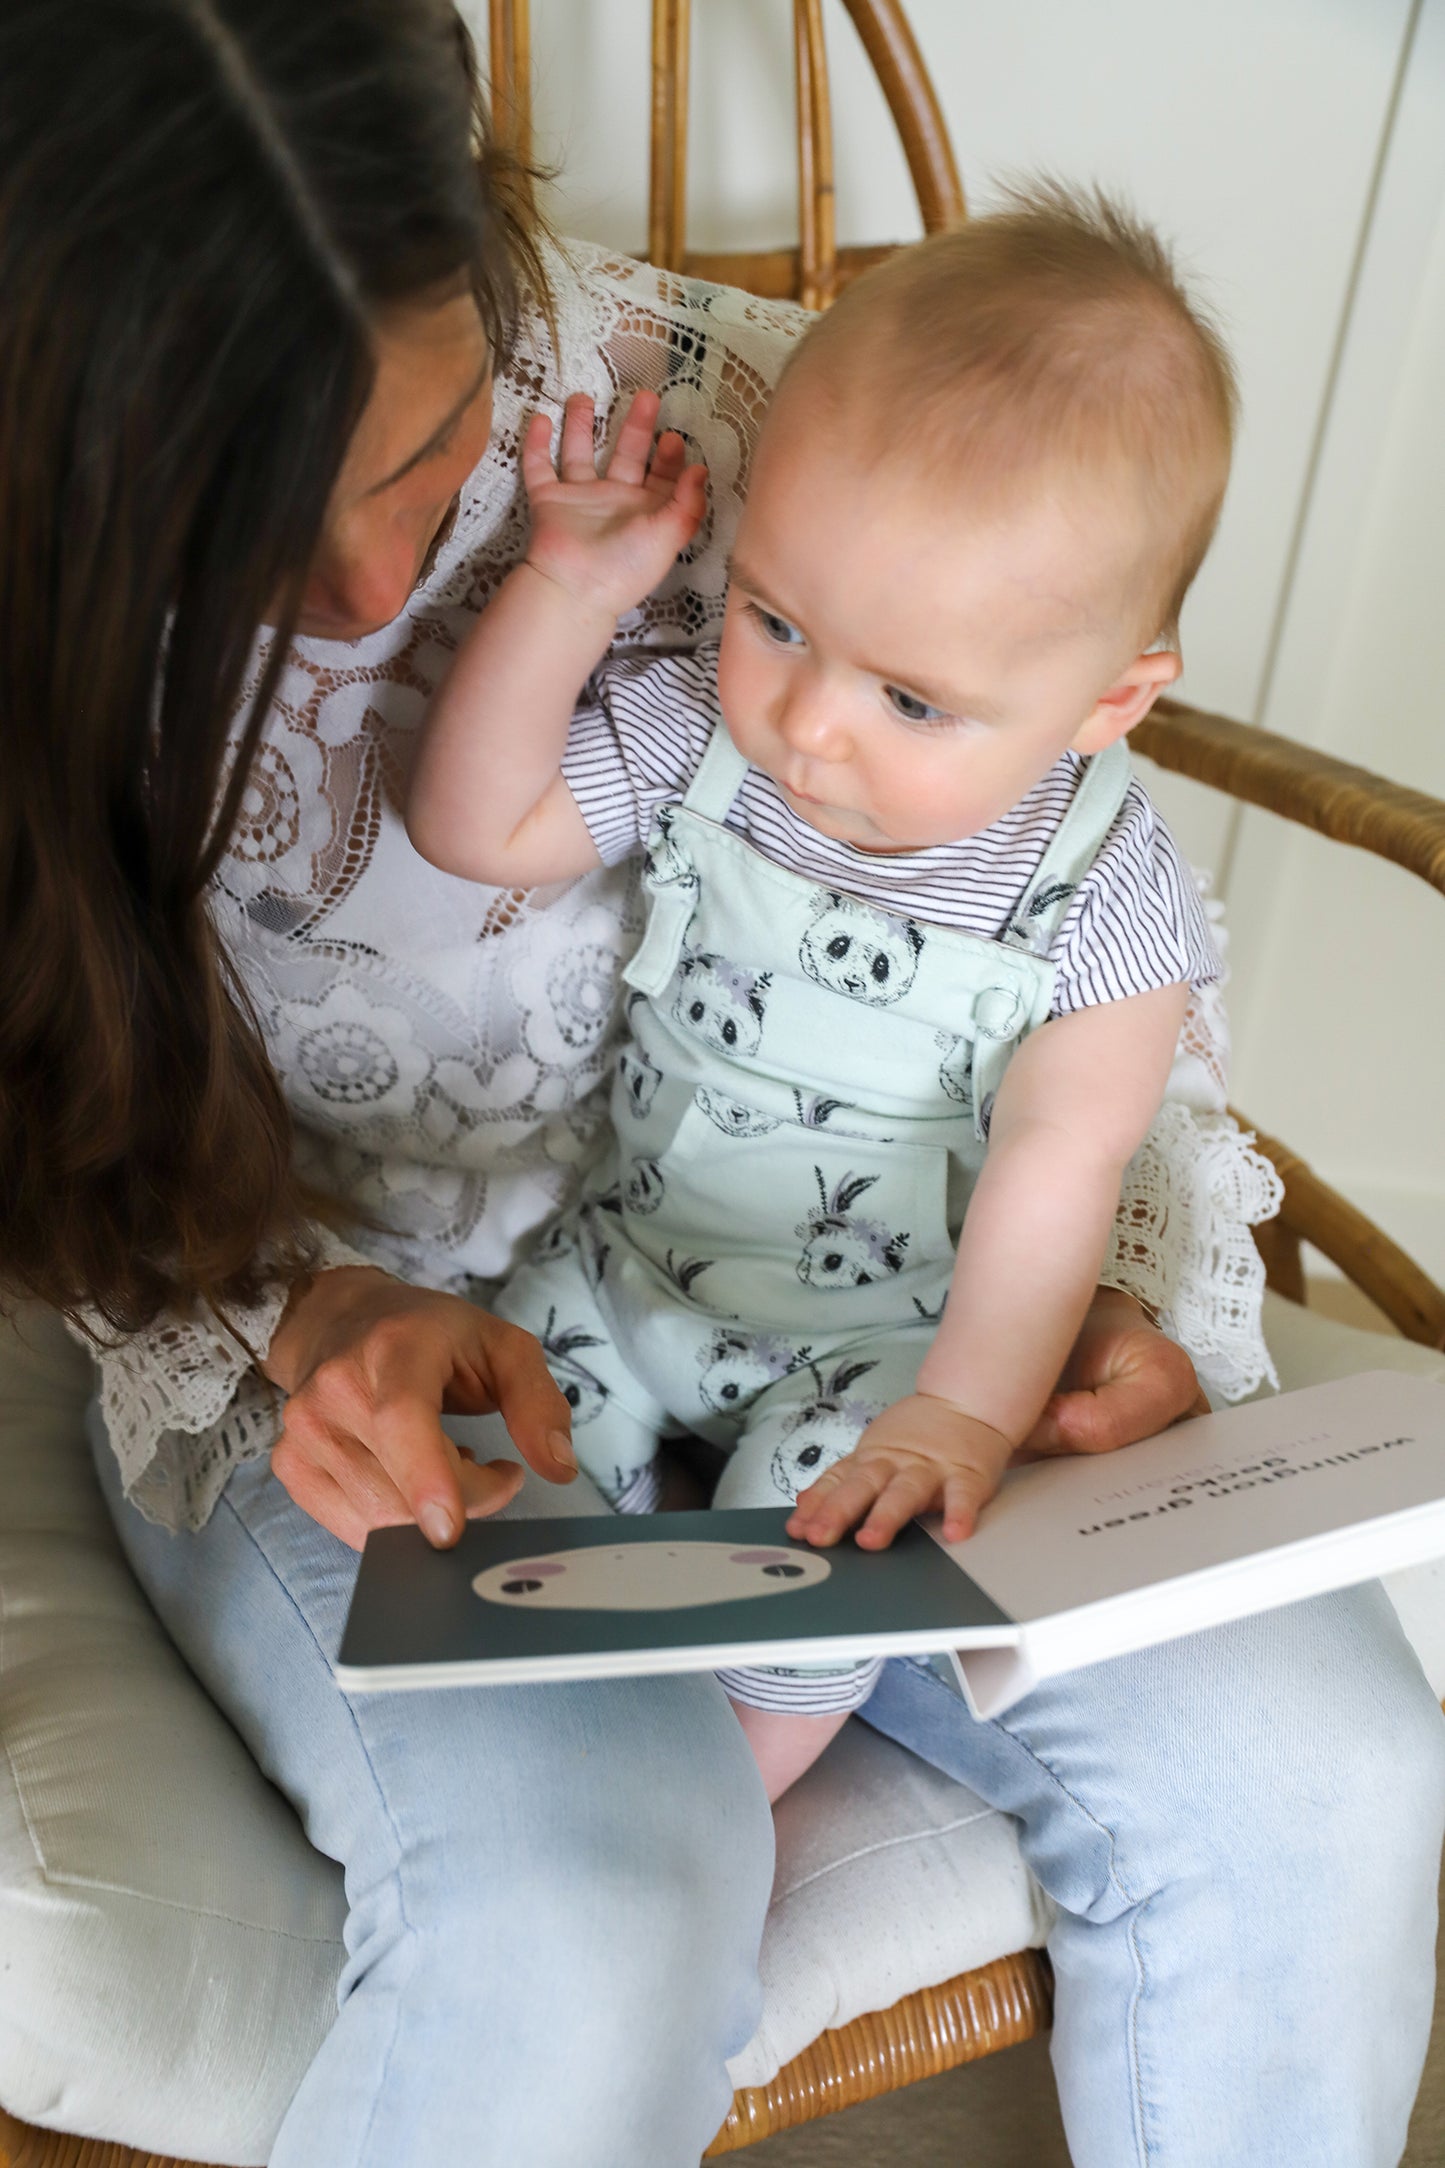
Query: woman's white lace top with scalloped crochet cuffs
81 245 1278 1528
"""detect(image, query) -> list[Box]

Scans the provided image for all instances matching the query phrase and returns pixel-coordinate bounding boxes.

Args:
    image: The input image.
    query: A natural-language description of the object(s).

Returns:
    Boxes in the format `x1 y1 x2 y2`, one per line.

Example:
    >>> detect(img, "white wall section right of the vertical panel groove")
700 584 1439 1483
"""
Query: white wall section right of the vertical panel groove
1228 0 1445 1283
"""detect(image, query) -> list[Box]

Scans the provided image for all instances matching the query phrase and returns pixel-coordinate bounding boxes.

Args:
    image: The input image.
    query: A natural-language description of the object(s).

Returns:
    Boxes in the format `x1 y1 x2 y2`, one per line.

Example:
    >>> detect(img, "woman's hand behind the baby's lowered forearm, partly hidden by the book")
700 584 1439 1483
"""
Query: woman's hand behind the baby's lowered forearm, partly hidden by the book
1014 1288 1209 1461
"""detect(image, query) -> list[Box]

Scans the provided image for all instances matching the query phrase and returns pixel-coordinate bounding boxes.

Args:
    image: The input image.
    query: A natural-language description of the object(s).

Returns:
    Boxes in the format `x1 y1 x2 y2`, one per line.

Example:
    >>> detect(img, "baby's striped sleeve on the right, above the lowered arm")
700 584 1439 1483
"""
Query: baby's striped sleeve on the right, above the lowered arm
1053 783 1222 1017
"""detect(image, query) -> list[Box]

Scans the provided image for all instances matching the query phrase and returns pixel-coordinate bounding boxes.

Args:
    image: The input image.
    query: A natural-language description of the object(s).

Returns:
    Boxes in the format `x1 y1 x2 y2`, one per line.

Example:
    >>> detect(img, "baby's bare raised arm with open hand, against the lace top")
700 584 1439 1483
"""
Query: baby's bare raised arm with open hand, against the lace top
407 392 704 887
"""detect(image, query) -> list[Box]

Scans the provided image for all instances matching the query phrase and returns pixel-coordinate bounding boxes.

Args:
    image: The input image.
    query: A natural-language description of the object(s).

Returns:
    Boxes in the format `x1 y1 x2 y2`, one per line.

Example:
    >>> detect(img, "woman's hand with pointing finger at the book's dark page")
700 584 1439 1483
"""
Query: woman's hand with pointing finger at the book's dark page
262 1266 576 1550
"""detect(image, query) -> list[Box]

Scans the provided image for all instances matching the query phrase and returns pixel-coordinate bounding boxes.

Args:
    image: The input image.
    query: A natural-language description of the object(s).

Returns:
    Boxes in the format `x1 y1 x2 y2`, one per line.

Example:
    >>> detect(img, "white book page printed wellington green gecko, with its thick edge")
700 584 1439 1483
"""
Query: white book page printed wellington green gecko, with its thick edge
940 1370 1445 1715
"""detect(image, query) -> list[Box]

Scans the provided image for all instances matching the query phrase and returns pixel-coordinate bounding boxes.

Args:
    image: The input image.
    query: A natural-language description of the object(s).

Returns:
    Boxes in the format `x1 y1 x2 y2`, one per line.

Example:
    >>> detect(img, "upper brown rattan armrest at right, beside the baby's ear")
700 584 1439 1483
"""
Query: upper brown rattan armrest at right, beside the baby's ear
1131 700 1445 895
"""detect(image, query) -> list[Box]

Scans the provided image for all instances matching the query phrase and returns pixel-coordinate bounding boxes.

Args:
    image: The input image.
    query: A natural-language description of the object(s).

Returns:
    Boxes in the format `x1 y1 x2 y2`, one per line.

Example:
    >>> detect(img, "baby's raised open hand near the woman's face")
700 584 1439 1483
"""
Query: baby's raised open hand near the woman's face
522 392 706 620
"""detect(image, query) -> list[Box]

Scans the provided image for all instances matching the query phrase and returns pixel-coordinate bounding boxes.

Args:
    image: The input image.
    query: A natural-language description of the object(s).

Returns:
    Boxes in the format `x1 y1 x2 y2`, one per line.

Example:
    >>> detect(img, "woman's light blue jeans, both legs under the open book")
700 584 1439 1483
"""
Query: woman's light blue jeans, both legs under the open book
100 1422 1445 2168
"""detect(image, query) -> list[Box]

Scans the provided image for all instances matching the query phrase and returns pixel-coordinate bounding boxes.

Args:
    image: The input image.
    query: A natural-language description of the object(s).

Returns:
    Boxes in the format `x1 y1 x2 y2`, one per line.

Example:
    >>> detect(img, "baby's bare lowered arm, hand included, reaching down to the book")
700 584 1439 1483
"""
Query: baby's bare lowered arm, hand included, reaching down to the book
789 986 1187 1548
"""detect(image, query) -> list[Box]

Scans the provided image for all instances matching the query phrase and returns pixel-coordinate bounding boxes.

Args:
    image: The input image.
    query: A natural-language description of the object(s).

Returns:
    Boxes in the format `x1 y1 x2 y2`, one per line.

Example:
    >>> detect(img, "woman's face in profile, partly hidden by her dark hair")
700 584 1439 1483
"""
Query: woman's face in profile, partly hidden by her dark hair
297 293 492 640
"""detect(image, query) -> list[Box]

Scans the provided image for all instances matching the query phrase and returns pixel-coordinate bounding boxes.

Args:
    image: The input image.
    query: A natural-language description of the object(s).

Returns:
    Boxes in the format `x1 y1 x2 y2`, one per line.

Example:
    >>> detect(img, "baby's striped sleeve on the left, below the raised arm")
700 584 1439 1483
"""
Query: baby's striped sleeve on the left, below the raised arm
561 650 717 865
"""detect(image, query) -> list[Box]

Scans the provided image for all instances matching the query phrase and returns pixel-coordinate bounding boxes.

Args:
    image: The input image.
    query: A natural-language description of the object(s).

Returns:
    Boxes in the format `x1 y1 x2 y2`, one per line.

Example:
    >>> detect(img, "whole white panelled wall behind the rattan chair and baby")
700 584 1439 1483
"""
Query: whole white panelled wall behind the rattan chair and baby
468 0 1445 1279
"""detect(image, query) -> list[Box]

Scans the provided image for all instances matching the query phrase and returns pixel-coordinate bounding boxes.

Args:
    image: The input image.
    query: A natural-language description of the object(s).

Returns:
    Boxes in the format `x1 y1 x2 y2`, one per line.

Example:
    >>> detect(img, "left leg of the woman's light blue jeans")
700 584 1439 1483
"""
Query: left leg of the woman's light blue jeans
97 1446 773 2168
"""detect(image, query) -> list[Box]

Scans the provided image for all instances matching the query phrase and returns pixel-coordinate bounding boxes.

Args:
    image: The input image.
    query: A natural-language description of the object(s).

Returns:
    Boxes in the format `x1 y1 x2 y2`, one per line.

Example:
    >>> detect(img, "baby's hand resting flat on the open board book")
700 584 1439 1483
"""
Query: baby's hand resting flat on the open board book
789 1392 1014 1550
